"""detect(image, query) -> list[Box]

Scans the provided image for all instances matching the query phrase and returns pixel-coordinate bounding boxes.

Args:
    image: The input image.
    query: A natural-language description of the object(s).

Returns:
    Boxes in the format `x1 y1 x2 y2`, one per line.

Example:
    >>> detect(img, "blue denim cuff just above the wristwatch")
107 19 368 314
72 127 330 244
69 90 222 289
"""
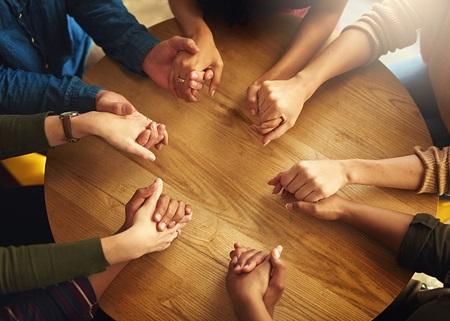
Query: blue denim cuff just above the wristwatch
64 77 102 112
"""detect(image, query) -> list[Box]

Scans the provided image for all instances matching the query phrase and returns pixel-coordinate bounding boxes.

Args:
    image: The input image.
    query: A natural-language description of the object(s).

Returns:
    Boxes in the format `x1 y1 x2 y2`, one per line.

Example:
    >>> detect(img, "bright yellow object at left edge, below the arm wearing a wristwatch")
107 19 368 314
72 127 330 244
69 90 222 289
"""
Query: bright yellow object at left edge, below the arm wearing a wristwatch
2 153 47 186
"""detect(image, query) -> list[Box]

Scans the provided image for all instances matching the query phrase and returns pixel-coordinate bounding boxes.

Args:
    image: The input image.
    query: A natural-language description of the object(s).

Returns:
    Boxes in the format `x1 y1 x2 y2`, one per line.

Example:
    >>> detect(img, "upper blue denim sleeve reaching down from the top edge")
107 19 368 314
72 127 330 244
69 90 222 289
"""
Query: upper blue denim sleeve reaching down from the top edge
66 0 158 73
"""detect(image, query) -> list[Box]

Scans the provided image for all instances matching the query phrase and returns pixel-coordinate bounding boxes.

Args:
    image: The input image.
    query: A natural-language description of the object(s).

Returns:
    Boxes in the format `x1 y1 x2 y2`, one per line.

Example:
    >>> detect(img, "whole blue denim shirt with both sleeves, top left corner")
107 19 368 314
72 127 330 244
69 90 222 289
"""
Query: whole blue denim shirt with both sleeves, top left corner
0 0 158 114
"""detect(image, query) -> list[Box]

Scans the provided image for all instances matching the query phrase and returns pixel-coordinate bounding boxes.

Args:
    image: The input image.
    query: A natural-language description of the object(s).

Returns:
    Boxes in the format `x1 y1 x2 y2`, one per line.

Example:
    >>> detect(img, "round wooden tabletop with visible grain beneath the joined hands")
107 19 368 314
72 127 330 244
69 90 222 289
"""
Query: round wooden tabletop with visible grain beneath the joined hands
45 16 437 321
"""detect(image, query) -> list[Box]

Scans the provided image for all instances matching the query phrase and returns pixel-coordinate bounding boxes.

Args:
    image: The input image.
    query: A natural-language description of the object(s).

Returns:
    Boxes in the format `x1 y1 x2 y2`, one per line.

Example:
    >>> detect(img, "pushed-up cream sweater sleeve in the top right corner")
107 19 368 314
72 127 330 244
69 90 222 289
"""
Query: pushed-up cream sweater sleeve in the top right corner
343 0 432 62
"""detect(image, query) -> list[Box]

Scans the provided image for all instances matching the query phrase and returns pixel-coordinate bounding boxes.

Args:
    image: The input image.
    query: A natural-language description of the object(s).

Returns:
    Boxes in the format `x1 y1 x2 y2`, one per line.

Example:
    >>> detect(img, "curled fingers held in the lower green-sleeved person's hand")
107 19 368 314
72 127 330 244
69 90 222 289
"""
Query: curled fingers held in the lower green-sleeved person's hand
153 194 192 231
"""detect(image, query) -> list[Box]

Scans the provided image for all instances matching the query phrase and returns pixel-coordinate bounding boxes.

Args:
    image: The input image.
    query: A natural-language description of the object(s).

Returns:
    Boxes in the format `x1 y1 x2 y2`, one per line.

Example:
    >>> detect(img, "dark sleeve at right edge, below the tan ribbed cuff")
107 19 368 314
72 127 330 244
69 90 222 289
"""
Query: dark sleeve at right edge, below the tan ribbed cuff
398 214 450 286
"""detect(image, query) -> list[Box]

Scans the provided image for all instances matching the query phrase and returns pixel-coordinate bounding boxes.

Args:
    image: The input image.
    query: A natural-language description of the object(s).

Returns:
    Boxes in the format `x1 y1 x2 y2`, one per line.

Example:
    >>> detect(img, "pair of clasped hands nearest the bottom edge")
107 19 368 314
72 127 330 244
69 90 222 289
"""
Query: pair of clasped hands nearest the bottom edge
227 244 285 315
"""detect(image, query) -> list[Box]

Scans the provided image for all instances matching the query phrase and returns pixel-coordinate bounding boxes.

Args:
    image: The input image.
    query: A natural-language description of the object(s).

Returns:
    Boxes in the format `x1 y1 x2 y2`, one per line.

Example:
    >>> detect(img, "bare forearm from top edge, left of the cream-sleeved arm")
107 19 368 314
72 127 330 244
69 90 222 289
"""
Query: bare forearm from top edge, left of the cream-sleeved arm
265 0 347 80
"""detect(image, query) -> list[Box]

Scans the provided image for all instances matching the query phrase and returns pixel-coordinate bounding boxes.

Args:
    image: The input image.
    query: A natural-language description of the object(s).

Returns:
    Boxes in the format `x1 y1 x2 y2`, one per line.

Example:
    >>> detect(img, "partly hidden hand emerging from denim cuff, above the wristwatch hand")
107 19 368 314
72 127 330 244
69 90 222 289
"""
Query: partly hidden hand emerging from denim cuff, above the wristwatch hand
95 90 136 116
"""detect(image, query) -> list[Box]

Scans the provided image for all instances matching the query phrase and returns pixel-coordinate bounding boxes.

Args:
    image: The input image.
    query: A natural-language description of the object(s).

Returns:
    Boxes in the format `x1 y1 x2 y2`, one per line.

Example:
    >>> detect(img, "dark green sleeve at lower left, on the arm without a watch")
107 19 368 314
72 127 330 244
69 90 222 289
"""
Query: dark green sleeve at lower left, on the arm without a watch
0 238 108 294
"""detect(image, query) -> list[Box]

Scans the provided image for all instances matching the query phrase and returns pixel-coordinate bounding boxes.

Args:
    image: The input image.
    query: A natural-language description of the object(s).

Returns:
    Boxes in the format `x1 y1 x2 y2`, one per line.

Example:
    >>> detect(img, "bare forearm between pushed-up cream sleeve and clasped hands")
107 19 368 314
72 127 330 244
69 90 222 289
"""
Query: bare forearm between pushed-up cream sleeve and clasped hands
297 29 371 99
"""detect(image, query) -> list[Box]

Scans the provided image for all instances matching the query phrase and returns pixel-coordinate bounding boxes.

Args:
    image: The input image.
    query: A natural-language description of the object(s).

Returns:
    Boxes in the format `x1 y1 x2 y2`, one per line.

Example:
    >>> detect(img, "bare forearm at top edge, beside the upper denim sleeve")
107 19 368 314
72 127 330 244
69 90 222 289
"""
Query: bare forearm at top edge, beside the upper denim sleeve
169 0 213 42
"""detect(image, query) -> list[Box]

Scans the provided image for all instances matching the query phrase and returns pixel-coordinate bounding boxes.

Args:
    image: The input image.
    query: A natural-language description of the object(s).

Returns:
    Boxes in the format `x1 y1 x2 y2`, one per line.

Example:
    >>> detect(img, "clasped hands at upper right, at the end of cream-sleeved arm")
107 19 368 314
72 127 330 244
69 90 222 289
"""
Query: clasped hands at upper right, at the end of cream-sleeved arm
247 76 306 145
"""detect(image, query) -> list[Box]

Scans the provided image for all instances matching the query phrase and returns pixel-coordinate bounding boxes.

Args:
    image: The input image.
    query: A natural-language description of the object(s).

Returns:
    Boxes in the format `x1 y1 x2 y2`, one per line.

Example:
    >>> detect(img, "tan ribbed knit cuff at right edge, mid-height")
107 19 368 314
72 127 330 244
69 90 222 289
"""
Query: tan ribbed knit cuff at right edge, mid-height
415 146 450 195
